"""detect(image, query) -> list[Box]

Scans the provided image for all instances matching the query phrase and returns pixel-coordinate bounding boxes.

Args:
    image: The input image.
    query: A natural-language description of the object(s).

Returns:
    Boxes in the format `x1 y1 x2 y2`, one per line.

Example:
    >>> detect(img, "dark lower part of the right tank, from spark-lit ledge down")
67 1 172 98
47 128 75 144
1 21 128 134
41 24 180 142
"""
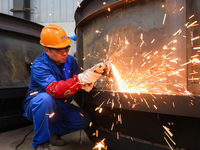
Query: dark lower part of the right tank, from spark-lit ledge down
83 91 200 150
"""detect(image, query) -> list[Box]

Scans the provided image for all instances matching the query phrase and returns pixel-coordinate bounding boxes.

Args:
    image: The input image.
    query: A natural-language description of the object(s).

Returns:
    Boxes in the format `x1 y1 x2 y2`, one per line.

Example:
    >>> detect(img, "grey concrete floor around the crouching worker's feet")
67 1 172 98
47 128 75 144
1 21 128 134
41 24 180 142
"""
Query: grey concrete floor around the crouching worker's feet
0 125 94 150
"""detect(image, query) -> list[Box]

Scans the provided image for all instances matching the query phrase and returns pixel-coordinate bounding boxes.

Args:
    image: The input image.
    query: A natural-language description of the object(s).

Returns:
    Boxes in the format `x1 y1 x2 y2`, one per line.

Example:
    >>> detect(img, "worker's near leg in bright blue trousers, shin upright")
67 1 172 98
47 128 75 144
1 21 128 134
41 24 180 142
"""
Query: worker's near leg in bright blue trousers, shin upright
26 93 55 148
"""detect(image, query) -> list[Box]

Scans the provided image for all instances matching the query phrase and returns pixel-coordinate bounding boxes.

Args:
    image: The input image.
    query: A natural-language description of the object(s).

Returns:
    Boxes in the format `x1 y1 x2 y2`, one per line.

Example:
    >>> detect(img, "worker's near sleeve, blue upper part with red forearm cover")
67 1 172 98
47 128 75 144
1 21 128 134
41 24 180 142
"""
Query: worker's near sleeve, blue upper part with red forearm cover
32 61 82 98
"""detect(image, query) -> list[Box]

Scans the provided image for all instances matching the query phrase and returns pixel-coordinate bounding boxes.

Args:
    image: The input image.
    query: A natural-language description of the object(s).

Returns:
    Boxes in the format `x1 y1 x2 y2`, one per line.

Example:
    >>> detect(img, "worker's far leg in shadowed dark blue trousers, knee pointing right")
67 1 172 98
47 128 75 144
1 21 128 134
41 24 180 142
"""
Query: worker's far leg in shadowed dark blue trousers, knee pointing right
51 104 90 136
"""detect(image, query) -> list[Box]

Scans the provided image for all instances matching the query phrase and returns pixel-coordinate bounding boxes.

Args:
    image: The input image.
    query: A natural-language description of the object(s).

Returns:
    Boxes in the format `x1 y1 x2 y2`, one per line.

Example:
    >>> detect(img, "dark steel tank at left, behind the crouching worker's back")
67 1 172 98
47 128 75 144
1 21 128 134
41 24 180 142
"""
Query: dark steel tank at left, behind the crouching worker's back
0 13 44 131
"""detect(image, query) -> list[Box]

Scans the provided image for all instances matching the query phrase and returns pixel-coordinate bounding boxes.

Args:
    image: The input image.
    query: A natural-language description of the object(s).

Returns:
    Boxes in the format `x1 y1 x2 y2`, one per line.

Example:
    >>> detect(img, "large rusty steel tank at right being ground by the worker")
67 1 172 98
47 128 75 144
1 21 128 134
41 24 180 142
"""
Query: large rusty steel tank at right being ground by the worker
75 0 200 150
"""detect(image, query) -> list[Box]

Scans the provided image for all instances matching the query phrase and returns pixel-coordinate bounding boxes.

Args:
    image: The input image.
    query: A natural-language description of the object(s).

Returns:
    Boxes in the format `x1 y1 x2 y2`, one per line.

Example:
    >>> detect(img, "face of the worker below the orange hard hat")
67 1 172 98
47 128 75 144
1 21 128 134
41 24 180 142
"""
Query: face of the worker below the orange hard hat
45 46 70 65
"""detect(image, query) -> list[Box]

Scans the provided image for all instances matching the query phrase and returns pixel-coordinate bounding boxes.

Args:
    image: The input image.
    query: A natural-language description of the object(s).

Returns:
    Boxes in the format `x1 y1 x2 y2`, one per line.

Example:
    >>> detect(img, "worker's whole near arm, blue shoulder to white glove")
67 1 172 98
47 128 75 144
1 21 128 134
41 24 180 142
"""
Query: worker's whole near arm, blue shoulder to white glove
32 61 105 98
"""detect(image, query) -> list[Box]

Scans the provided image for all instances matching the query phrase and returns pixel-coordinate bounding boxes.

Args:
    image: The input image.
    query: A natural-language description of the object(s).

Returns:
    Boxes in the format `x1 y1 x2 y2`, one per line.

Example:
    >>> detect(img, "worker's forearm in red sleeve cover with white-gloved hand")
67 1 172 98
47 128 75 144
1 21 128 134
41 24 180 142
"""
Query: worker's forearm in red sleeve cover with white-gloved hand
46 63 105 98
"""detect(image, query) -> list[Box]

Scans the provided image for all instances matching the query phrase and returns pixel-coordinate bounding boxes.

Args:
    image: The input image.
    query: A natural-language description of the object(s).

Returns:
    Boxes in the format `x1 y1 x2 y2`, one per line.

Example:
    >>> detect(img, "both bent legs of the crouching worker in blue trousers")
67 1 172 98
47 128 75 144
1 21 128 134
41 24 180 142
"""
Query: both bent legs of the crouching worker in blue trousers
25 92 90 148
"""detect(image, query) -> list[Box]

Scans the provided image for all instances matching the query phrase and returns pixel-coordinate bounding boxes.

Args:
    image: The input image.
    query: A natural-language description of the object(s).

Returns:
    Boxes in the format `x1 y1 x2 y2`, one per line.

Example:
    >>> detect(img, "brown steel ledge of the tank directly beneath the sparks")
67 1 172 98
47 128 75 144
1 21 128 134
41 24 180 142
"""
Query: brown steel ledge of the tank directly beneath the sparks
84 90 200 118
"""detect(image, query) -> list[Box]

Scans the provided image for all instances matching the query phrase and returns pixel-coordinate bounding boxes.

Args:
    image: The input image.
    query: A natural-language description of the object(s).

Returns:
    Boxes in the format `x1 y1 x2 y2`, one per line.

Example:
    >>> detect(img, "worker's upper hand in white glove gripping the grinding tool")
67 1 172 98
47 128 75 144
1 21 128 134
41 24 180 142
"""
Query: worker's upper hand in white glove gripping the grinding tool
78 63 106 85
